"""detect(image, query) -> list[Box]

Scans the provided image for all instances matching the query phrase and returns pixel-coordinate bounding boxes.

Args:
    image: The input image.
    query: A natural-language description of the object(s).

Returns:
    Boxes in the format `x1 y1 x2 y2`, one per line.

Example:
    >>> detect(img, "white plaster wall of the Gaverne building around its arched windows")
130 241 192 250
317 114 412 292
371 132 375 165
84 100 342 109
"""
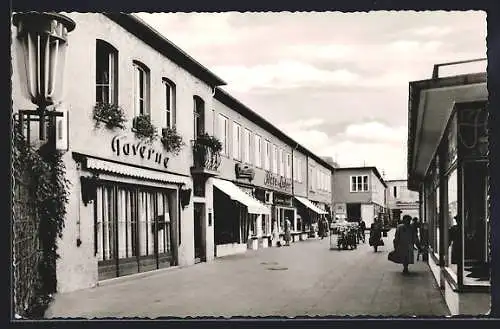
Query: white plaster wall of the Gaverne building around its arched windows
11 13 213 292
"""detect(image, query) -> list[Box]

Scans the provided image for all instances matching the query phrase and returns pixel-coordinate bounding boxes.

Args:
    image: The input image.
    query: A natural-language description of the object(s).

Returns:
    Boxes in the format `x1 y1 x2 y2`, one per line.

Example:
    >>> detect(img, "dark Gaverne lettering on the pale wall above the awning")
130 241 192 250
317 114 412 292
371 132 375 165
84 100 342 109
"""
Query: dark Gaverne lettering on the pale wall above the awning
110 135 169 169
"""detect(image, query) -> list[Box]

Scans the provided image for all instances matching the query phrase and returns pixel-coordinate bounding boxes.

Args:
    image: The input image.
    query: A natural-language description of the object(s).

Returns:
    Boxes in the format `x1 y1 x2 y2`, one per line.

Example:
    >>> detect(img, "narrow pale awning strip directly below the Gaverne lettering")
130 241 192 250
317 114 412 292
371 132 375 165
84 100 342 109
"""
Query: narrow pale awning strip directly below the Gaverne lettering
86 157 187 184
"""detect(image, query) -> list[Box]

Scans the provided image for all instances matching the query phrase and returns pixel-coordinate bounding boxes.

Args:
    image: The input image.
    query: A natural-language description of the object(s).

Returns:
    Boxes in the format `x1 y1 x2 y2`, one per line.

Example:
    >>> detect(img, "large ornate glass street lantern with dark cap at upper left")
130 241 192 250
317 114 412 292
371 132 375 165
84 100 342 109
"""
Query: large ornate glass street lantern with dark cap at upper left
13 12 75 142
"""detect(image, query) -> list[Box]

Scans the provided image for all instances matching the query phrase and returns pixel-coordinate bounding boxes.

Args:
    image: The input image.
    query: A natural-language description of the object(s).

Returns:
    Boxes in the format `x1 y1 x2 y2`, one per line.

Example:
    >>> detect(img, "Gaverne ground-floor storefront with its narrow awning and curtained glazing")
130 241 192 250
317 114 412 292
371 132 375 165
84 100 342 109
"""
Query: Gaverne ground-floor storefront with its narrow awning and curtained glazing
73 152 187 281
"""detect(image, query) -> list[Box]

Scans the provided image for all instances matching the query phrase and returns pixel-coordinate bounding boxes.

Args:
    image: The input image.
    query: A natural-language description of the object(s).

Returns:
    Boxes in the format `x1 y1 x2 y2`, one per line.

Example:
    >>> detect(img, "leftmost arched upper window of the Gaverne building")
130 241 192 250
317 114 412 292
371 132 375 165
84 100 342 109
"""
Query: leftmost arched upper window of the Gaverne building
95 40 118 104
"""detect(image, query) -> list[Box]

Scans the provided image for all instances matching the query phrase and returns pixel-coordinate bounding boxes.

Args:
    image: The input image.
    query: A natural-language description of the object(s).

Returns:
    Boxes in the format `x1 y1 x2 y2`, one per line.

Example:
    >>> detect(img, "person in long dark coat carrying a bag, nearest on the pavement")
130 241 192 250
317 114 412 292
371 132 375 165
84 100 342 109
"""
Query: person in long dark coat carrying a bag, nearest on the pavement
394 215 420 274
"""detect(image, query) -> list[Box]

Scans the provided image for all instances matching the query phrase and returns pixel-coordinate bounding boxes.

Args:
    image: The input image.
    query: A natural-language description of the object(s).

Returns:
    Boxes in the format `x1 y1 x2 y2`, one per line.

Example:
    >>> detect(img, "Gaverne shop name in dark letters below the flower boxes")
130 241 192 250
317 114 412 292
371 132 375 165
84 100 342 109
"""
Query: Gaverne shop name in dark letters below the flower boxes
111 135 169 168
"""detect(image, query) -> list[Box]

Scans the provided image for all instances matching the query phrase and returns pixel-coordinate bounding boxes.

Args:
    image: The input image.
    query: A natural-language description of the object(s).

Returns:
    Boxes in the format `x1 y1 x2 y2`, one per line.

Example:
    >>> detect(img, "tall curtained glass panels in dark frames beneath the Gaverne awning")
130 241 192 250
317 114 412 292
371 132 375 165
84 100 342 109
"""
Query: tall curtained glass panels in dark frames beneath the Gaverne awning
94 182 175 280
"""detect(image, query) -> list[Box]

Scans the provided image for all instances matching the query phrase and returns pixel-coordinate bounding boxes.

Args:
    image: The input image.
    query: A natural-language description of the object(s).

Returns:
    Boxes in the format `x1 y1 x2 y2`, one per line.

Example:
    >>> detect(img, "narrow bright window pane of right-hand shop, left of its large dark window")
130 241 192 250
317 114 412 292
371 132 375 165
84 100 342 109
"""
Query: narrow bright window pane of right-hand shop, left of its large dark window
445 168 461 276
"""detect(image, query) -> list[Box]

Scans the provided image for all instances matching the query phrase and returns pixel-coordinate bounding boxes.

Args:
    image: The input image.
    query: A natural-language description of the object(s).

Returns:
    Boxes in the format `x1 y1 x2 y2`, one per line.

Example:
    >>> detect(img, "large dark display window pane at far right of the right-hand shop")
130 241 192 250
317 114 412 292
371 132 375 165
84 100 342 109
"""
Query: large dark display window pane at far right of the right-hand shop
463 161 491 285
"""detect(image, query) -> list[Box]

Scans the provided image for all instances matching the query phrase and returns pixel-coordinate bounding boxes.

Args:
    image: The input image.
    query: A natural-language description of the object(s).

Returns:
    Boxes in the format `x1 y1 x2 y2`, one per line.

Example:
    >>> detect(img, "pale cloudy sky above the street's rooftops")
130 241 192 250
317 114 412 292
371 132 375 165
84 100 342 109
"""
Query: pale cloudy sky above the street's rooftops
136 11 487 179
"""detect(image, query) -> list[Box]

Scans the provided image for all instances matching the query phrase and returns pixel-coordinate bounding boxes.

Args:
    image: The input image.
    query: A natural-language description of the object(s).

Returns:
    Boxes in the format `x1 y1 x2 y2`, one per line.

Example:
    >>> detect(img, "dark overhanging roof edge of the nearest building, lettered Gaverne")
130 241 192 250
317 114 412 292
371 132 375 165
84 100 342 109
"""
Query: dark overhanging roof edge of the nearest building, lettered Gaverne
104 13 226 87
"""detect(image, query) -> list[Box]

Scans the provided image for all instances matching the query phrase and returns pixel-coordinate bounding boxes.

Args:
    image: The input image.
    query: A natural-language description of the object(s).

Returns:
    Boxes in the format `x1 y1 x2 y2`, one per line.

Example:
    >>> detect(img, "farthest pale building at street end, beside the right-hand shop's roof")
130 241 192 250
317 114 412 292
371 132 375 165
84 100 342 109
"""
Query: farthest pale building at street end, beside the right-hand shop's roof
385 179 419 223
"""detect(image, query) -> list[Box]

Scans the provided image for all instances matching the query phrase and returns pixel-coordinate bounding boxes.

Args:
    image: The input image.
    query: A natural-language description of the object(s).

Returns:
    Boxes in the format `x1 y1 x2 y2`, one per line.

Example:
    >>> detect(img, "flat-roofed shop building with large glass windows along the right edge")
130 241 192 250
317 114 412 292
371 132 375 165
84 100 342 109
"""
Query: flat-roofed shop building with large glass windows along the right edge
408 60 491 315
